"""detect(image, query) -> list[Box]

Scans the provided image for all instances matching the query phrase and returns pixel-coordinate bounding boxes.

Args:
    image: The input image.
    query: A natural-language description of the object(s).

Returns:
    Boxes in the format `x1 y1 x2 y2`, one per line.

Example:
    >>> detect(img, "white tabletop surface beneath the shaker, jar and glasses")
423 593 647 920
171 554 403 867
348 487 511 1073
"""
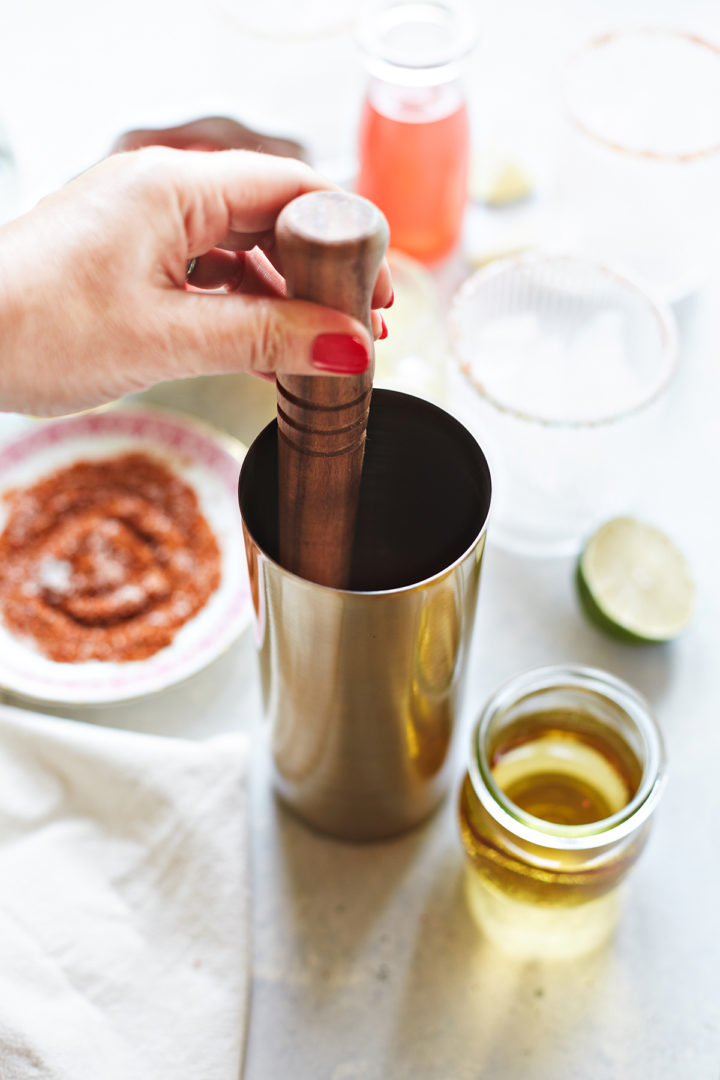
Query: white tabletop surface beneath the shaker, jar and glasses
0 0 720 1080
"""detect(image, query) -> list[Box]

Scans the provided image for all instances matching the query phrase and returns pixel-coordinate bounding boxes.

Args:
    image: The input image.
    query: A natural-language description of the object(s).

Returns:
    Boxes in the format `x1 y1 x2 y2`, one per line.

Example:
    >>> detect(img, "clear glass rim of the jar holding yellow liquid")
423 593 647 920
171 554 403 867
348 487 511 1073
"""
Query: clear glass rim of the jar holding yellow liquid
468 664 666 851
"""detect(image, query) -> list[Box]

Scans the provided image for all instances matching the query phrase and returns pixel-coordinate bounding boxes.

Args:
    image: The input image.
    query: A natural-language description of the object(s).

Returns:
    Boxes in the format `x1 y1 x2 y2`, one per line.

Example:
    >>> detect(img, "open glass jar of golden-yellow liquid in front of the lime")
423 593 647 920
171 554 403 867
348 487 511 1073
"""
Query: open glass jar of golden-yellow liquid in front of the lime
460 665 665 957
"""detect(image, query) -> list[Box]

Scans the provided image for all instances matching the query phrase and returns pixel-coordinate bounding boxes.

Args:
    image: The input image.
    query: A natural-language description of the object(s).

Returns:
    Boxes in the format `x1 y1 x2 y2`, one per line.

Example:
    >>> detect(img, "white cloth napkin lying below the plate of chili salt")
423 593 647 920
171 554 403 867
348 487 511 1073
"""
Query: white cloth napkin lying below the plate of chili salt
0 705 249 1080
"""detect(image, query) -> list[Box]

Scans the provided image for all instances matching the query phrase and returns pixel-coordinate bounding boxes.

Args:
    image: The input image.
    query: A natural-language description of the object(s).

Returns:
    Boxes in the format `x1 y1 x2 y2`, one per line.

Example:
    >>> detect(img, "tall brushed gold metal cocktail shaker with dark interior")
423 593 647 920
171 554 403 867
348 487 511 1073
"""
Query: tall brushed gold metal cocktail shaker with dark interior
240 390 490 840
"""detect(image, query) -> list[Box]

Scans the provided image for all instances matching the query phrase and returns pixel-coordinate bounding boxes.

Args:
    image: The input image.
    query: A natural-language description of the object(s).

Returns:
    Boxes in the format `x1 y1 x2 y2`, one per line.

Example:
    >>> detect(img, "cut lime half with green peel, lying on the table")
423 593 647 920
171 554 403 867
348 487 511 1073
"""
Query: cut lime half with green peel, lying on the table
578 517 695 643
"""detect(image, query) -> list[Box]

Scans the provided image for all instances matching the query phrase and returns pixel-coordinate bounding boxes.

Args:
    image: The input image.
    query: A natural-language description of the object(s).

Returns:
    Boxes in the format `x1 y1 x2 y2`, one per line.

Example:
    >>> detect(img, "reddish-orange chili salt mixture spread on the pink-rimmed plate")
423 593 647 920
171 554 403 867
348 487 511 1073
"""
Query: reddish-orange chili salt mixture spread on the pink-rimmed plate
0 453 220 663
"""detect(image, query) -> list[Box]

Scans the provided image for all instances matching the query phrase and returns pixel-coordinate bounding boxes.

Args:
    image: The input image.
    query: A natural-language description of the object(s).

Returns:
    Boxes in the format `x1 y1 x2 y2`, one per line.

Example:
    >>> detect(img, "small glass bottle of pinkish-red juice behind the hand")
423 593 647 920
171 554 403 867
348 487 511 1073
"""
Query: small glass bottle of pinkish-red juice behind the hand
357 0 475 262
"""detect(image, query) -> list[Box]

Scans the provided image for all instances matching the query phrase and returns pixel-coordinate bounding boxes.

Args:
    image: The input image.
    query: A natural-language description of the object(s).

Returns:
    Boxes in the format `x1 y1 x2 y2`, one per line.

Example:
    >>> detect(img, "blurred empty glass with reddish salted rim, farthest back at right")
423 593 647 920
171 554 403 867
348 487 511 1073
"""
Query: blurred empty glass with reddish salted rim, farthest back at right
558 27 720 301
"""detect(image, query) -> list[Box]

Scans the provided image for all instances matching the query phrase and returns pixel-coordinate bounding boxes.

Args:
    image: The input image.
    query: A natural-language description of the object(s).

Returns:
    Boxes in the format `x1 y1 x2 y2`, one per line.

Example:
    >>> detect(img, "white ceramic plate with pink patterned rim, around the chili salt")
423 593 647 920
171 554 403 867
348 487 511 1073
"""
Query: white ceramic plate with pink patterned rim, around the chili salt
0 407 253 705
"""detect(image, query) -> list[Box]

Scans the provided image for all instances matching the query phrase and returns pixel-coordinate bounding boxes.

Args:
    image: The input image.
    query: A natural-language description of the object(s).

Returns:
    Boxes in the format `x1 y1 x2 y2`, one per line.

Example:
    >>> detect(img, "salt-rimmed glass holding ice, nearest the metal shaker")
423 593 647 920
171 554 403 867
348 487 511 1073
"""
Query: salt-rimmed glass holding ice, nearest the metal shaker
448 254 676 555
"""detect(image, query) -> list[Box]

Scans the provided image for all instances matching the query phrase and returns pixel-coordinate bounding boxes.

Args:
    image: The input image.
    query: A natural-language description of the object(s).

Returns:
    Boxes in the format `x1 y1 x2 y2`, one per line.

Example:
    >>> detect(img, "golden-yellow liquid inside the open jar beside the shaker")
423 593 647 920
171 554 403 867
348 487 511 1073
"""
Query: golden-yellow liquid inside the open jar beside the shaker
460 710 646 956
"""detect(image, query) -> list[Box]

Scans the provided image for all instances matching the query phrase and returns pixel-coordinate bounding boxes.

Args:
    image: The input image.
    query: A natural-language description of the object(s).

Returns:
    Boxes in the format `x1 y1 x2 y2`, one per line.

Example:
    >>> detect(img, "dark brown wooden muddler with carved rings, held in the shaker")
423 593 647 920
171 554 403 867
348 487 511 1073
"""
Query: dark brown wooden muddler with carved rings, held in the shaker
275 191 388 589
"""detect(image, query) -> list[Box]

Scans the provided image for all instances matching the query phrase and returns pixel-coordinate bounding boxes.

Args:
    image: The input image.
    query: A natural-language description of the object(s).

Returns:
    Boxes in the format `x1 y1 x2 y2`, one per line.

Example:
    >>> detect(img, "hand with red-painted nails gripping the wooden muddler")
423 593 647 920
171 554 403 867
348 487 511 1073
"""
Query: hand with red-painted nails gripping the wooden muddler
0 147 392 416
